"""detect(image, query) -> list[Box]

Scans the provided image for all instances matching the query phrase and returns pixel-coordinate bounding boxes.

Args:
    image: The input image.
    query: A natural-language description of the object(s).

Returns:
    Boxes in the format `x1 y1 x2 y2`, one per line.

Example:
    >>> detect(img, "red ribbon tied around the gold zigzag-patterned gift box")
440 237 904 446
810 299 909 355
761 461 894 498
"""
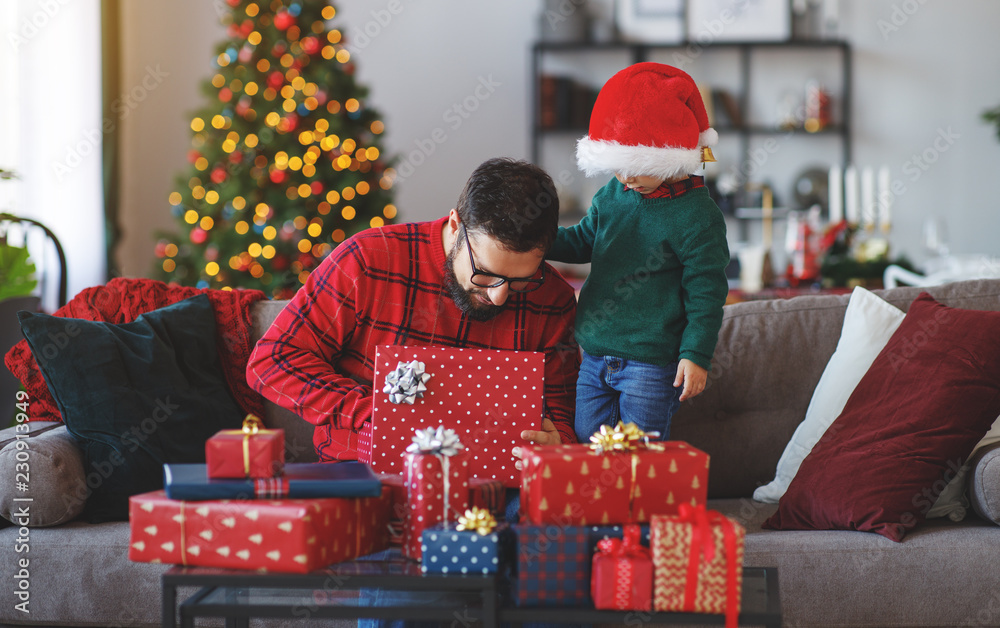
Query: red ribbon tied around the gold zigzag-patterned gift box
678 504 742 628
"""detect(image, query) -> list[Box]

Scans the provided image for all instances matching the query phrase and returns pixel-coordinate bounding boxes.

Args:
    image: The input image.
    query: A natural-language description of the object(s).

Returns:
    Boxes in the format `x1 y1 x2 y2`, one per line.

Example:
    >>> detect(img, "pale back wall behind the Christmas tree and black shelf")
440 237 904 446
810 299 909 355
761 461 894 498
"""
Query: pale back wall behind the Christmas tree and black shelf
120 0 1000 275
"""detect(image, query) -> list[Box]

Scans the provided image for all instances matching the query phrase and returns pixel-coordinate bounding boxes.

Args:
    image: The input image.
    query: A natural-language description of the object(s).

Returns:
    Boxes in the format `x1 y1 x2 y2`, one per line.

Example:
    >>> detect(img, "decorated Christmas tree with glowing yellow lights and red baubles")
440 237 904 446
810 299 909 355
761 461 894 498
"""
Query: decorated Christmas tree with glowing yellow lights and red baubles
156 0 396 298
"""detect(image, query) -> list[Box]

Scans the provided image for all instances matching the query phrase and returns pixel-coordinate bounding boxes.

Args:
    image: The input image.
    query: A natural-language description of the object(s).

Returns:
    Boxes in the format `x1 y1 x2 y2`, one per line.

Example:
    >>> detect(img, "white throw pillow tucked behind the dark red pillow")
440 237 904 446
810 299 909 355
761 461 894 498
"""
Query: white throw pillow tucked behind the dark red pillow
753 287 906 504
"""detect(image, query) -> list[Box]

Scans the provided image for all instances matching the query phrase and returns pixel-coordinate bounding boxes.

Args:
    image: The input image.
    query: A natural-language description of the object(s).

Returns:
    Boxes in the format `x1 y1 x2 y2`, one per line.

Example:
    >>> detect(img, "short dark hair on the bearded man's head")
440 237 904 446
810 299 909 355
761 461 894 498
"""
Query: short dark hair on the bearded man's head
456 157 559 253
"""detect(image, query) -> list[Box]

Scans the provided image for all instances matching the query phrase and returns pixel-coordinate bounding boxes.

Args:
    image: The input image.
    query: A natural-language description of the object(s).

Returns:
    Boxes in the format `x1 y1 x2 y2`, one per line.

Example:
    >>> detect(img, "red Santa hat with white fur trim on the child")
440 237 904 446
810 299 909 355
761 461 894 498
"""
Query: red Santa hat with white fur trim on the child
576 62 719 179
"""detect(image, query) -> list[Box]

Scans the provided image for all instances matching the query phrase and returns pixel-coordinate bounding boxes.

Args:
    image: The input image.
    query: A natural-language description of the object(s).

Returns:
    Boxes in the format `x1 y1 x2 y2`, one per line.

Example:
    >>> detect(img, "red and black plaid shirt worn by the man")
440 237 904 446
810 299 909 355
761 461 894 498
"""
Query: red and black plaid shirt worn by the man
247 218 579 460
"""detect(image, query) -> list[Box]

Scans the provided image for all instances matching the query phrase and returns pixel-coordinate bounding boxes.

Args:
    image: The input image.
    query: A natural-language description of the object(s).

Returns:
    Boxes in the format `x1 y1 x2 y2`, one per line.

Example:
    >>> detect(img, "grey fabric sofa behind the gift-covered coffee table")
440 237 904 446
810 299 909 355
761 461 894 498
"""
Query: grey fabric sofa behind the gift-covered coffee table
0 280 1000 627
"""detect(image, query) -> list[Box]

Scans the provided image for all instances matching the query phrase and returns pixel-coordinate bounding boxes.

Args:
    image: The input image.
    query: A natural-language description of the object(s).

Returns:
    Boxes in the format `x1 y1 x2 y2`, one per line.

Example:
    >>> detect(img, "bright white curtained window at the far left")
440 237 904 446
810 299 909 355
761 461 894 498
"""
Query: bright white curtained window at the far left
0 0 105 311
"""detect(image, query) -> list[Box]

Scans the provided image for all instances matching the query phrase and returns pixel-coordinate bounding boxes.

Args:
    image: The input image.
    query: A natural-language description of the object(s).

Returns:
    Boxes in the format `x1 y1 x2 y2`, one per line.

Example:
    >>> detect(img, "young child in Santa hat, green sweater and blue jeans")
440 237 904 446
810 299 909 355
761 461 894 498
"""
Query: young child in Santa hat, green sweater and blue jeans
547 63 729 442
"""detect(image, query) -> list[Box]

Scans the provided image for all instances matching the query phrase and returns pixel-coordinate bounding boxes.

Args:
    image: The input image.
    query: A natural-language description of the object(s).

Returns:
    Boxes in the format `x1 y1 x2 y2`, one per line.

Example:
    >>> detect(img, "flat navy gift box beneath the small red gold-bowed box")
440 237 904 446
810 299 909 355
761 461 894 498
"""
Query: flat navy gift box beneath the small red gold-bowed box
163 461 382 501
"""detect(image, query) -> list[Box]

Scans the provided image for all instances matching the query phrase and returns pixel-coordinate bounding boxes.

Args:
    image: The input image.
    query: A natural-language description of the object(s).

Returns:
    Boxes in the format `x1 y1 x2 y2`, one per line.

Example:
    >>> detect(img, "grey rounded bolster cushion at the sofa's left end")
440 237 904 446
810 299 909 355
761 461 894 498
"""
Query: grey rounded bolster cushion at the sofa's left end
0 425 87 527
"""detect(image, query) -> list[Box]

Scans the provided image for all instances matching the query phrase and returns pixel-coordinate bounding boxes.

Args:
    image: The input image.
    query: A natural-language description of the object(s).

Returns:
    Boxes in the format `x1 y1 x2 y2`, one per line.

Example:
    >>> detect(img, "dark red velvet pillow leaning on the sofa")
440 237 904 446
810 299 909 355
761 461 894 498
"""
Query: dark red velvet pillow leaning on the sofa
764 292 1000 541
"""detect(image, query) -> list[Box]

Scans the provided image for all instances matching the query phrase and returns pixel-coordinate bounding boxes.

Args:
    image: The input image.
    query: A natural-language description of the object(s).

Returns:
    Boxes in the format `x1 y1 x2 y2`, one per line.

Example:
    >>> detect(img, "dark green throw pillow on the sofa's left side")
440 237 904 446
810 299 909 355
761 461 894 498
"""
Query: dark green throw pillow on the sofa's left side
18 295 243 523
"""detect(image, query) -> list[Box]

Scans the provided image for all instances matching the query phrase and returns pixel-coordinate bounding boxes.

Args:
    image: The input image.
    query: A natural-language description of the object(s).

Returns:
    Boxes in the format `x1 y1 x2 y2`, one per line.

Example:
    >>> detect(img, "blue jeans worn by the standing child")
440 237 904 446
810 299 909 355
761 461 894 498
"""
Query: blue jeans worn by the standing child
574 351 683 443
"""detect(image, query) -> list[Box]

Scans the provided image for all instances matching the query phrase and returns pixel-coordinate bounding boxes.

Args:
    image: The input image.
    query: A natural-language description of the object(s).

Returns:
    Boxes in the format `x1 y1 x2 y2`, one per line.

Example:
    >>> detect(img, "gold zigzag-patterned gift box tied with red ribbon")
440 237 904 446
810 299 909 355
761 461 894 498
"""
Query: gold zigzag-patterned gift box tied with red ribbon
650 504 746 628
